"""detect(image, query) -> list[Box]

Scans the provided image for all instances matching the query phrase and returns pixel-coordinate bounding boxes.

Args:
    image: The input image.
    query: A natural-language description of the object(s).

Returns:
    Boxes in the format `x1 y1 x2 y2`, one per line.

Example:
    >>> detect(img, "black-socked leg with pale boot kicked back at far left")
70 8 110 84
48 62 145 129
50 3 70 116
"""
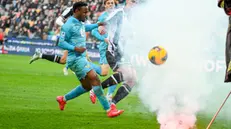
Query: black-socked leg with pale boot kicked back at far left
30 51 66 64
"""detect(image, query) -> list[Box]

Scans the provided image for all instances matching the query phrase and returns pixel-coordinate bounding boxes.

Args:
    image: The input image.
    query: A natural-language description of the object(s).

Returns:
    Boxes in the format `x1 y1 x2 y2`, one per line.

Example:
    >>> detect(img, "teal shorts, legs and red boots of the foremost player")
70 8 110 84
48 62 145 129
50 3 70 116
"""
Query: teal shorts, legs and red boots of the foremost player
57 59 123 117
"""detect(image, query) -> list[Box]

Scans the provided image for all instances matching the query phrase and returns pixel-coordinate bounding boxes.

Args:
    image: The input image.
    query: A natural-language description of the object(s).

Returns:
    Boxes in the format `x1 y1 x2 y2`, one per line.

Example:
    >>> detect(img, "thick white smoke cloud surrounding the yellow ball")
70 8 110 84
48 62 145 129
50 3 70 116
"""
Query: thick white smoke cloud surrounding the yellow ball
123 0 231 128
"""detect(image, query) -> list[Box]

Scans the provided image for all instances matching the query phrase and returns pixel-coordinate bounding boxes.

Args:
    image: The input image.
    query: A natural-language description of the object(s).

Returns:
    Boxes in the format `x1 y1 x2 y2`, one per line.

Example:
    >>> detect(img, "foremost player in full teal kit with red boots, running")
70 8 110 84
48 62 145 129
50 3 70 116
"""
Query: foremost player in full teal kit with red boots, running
57 2 123 117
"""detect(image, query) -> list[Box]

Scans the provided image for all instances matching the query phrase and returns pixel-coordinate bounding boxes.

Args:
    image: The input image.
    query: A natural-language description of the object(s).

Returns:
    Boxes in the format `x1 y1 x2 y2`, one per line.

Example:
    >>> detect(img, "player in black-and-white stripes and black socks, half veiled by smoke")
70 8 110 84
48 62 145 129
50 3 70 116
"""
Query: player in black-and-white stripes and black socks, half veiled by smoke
90 0 136 105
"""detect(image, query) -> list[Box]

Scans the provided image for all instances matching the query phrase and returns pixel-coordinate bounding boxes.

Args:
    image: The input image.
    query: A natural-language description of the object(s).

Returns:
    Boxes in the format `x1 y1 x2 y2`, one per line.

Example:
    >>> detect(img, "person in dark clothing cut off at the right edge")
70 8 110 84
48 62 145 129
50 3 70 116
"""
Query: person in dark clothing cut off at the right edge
218 0 231 82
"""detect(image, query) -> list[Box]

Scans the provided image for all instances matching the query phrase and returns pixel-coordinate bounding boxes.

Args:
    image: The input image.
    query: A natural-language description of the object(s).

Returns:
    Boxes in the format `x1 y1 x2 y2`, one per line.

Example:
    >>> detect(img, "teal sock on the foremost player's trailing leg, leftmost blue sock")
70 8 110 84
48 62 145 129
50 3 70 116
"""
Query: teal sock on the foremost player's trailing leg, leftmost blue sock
64 85 87 101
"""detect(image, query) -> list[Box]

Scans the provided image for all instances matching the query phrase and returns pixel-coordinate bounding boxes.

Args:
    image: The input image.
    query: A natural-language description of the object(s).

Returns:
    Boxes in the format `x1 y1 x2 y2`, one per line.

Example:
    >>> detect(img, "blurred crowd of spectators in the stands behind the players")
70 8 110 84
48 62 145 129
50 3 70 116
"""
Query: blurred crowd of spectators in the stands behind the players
0 0 122 41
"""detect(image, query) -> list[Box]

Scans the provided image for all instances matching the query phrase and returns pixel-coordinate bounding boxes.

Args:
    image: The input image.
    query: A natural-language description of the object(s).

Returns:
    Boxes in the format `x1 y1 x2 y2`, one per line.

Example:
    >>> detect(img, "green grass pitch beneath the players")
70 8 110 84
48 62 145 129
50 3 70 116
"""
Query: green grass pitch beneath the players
0 55 231 129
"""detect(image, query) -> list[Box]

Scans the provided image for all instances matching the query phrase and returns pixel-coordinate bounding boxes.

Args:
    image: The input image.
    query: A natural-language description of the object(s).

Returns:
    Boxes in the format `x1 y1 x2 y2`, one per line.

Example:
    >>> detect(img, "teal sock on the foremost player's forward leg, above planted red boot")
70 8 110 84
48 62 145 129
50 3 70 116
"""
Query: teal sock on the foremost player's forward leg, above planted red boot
92 86 110 110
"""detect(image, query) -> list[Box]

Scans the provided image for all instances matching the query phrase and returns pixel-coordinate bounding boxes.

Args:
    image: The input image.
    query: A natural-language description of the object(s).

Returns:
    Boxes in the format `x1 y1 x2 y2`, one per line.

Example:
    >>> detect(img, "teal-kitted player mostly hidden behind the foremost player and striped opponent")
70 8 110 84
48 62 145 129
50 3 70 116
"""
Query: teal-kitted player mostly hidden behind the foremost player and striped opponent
90 0 116 103
